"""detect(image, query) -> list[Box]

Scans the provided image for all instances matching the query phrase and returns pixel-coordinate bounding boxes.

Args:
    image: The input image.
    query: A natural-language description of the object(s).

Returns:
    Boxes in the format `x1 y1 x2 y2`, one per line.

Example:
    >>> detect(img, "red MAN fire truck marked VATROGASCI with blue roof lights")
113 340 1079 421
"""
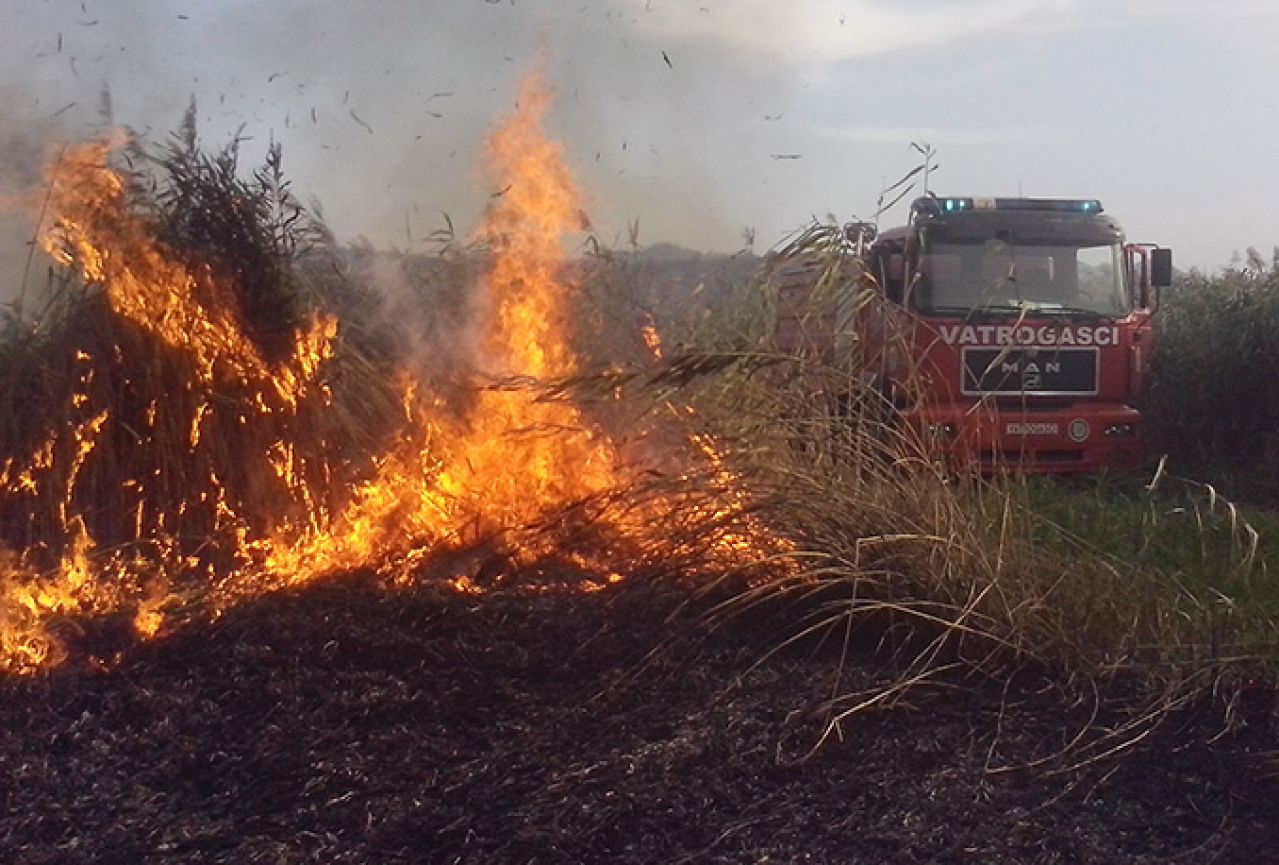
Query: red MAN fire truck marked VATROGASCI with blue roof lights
774 194 1172 473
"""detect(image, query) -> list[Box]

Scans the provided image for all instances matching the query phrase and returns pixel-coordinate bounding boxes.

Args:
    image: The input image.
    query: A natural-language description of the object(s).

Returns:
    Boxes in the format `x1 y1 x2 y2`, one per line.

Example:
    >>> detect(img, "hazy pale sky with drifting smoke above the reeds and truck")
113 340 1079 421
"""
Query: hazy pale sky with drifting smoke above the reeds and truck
0 0 1279 270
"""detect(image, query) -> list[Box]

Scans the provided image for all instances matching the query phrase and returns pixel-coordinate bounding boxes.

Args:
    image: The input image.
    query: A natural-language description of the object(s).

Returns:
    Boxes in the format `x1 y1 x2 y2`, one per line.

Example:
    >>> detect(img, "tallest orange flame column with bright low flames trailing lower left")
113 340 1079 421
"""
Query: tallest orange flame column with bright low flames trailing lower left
239 79 619 582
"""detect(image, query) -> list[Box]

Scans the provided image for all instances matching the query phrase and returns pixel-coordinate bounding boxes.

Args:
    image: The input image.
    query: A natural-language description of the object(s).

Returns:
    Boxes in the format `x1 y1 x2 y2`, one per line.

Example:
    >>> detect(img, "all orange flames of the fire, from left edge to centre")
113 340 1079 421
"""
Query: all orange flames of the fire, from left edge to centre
0 77 782 673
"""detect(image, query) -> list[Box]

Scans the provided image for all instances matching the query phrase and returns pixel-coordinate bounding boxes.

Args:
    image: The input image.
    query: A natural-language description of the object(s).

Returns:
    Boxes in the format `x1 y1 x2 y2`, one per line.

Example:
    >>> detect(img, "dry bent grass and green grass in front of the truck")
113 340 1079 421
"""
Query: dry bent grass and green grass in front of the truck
665 353 1279 752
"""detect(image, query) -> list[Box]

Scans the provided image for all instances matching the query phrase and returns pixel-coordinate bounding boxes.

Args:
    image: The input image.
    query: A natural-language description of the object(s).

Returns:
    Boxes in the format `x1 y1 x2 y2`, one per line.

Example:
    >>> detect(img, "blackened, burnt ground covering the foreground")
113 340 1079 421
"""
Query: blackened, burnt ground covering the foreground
0 576 1279 865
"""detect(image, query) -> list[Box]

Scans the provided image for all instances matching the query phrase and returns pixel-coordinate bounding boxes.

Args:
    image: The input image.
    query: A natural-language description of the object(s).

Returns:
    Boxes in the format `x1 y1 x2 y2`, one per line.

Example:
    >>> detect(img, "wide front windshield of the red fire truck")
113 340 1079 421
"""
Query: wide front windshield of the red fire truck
911 238 1131 317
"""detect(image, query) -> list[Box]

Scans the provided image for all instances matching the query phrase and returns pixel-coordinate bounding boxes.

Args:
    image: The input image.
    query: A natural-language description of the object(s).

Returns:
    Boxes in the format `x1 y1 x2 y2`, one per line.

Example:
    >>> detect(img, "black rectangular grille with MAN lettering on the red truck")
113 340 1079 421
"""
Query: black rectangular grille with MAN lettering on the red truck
962 347 1099 397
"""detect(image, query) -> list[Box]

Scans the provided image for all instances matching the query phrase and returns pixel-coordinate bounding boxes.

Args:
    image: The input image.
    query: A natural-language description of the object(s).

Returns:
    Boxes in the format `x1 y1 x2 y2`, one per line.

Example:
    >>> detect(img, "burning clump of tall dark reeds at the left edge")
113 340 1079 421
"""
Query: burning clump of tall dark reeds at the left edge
0 128 398 669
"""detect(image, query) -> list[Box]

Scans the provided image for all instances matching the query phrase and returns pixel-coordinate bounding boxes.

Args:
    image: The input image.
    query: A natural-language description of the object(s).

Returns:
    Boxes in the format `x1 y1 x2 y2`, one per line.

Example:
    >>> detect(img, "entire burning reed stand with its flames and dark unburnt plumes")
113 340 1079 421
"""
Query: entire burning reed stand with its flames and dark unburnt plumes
0 81 767 672
